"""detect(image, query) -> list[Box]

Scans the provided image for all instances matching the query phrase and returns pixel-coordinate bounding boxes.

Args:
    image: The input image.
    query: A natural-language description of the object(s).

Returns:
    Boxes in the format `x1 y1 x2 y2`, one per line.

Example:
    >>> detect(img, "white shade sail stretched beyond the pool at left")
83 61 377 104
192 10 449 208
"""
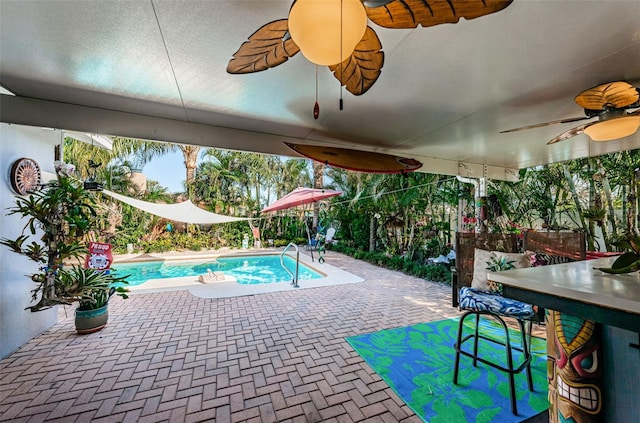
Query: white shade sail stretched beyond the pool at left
102 189 249 225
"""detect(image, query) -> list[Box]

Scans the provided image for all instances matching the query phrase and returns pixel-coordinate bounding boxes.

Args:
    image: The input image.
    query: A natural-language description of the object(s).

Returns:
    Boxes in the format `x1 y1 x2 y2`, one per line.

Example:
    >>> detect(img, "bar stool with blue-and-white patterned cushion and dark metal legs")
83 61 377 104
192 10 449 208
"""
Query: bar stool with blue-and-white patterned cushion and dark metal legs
453 287 539 415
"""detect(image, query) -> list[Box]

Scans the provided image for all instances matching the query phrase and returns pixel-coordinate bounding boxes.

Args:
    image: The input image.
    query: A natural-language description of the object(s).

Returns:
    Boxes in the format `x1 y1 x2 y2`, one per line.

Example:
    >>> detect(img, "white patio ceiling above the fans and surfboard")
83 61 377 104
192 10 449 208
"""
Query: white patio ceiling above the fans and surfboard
0 0 640 179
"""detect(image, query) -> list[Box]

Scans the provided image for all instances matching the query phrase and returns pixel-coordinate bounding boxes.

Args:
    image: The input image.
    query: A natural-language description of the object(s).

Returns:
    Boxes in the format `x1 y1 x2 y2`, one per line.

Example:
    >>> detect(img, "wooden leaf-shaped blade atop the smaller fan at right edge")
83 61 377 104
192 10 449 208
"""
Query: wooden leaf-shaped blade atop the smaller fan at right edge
574 81 640 110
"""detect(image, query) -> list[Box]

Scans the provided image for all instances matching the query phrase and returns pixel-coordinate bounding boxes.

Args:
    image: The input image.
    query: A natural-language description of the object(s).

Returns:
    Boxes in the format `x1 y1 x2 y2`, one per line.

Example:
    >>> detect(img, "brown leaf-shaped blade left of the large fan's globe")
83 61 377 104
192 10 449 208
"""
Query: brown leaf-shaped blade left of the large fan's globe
227 19 300 74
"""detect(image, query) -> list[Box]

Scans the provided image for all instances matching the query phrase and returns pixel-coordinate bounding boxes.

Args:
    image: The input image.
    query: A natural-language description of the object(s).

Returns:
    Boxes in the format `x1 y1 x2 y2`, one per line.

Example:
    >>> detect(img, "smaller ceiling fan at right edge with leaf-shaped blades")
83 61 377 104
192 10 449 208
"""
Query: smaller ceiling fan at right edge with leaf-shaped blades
500 81 640 144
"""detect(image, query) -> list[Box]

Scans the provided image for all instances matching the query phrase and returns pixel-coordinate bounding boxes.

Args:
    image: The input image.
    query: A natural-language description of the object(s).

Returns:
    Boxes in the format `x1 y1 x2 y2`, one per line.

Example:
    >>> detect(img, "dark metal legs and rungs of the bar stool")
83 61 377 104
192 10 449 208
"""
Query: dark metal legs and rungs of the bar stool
453 311 533 415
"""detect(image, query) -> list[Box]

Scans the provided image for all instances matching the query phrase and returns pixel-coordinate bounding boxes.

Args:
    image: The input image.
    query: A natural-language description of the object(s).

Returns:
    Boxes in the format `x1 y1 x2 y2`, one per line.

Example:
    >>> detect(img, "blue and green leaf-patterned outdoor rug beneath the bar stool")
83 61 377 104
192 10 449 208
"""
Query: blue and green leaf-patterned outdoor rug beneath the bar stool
347 319 549 423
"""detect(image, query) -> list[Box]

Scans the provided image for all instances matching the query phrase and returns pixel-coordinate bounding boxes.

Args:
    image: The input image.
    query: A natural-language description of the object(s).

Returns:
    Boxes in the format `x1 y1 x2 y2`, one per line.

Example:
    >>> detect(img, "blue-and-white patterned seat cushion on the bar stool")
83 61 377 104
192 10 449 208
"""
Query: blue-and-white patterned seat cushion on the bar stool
460 287 536 319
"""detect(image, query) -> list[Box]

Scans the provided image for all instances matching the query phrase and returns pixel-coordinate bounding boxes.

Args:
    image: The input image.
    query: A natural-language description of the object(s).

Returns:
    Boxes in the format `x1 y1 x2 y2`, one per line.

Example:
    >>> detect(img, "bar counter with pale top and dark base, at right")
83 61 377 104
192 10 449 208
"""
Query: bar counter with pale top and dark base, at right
488 257 640 423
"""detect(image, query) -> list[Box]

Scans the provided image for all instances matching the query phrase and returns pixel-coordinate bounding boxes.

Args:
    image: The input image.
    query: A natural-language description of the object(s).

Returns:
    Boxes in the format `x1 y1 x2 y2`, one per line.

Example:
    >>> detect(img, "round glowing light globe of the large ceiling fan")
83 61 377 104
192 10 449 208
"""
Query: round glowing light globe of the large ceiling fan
289 0 367 66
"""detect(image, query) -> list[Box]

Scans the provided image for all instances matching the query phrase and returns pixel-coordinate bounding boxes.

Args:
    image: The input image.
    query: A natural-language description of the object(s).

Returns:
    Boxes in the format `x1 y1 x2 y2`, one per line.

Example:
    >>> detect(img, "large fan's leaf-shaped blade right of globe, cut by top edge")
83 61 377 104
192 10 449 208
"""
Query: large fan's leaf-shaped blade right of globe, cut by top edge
363 0 513 28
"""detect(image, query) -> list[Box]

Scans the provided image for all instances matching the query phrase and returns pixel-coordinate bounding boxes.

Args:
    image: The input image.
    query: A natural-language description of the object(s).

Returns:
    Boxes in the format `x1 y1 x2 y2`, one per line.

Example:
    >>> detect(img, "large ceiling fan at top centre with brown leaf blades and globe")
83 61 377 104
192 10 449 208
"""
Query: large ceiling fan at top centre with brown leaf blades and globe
227 0 513 95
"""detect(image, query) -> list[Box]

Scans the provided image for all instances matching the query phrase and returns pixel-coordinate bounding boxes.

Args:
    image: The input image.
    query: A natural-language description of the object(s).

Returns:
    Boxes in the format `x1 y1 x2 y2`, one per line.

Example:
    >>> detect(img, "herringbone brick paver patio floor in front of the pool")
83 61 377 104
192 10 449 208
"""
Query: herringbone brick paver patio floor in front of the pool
0 252 458 423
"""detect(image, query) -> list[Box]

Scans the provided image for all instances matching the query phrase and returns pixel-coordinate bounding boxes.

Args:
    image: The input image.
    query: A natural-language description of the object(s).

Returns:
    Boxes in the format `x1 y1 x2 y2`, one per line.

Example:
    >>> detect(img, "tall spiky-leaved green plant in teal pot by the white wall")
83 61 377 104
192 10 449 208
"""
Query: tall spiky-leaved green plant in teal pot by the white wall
0 164 126 331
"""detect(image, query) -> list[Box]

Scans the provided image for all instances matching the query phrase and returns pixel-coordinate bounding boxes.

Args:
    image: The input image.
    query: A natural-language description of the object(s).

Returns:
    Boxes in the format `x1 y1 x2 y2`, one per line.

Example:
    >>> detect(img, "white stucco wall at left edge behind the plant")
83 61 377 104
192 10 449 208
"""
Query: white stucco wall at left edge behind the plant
0 123 60 358
